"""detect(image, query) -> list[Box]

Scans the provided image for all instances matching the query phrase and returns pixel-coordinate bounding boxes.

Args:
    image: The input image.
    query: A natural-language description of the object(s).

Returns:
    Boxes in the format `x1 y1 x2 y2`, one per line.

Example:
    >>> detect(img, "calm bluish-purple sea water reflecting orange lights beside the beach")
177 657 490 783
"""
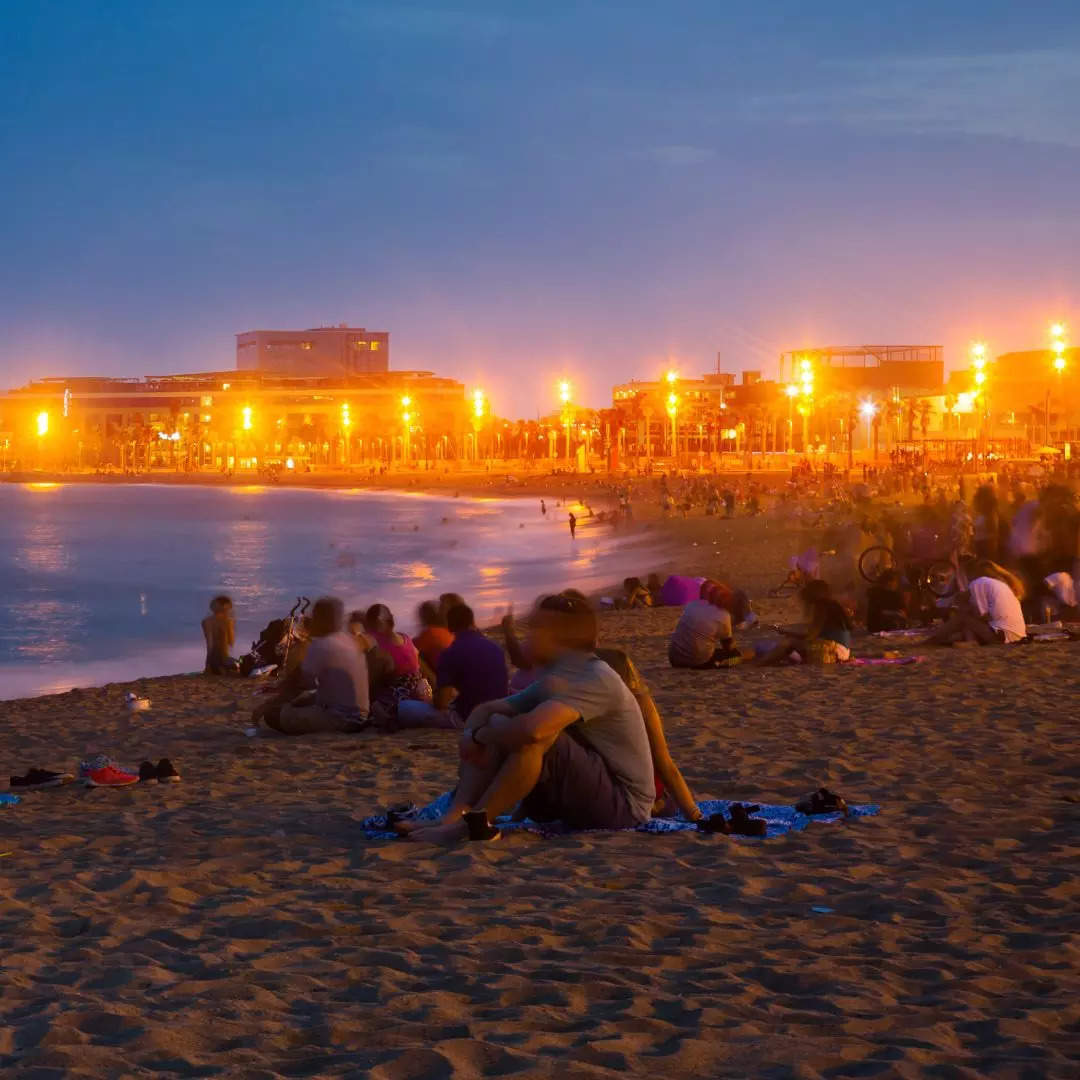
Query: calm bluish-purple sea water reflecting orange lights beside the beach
0 484 647 698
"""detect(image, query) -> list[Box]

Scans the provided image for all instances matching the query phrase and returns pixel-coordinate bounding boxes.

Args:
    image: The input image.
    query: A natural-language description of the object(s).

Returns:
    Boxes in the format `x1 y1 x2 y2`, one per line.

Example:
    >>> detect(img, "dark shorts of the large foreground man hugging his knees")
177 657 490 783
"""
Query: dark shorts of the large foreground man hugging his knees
522 731 642 828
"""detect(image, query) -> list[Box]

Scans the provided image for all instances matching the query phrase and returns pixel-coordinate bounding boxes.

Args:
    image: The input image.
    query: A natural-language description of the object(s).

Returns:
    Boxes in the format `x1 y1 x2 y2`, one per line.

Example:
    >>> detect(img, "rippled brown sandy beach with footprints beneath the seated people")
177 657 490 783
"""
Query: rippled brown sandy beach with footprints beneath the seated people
0 517 1080 1080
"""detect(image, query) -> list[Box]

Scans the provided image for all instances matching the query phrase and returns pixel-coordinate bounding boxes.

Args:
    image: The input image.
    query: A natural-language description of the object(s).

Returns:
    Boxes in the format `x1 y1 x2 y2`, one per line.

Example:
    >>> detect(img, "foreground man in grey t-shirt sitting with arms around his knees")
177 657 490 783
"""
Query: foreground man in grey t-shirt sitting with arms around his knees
403 595 656 843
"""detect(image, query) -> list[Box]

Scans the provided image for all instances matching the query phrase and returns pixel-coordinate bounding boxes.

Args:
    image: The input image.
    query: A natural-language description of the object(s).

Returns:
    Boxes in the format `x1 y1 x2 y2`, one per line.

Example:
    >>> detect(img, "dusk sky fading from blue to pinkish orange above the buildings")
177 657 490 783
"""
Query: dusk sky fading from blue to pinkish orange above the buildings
0 0 1080 416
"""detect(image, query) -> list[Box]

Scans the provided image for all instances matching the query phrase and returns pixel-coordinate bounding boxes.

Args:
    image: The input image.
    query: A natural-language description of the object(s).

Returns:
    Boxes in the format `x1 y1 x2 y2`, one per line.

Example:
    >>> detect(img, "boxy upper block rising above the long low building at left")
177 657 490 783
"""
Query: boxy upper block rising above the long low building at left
237 323 390 377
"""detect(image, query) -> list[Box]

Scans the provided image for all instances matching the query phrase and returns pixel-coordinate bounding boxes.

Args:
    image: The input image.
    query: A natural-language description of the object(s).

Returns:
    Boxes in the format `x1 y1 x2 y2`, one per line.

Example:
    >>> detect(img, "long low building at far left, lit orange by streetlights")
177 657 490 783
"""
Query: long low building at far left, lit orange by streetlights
0 328 477 471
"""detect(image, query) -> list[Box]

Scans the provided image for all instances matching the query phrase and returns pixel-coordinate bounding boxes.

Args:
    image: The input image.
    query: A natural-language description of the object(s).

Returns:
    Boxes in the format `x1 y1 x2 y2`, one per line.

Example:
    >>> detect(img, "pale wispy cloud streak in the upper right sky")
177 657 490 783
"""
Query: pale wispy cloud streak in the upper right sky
747 48 1080 148
